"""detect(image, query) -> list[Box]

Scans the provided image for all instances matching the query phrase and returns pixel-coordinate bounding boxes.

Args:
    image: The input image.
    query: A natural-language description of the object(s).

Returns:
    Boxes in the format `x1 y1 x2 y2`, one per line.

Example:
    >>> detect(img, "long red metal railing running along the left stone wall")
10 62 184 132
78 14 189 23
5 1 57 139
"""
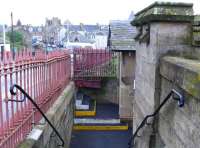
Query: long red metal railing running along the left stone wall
0 51 71 148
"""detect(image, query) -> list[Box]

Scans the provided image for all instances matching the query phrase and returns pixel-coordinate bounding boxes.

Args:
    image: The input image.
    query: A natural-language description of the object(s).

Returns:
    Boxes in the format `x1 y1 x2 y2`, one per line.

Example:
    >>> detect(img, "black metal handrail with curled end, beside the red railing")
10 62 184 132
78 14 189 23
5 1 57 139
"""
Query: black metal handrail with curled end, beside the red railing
8 84 65 147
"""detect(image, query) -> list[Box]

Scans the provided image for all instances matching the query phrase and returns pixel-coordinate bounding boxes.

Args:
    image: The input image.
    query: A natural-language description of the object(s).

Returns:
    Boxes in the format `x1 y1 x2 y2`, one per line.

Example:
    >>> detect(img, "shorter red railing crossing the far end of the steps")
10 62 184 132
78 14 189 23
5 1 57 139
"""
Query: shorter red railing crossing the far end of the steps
73 49 117 88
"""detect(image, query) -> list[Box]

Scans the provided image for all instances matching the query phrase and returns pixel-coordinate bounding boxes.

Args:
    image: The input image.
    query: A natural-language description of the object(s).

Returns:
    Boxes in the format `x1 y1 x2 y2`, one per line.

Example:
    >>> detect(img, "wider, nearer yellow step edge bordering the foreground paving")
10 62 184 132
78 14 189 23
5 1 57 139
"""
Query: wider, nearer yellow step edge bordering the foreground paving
73 125 128 131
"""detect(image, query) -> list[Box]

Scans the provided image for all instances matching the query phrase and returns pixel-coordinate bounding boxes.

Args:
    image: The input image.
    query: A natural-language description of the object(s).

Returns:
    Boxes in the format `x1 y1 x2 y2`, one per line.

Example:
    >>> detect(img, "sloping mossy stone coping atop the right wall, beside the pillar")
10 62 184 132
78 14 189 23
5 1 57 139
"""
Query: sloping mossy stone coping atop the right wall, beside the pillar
160 56 200 99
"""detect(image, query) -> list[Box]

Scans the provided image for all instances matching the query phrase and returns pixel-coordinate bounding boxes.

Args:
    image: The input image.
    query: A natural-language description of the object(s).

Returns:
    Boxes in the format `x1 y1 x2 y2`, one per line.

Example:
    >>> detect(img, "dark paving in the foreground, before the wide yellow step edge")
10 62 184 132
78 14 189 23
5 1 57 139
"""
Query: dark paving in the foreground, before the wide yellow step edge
70 129 132 148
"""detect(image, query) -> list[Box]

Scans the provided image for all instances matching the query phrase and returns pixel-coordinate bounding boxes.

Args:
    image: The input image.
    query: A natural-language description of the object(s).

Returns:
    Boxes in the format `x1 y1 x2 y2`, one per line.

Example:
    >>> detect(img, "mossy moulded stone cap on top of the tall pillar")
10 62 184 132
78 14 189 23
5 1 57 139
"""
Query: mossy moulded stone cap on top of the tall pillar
131 2 193 26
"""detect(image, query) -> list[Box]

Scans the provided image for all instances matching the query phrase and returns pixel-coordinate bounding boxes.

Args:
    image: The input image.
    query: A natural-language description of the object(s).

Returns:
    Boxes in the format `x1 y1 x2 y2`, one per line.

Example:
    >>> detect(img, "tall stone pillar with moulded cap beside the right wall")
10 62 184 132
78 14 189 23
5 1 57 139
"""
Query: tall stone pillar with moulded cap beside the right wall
132 2 193 148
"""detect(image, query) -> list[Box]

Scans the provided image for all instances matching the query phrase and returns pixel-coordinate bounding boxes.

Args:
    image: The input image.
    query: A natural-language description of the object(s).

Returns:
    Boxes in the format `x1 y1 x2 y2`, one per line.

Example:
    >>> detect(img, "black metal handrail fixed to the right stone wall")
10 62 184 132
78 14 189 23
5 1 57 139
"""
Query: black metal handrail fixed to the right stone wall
128 89 185 148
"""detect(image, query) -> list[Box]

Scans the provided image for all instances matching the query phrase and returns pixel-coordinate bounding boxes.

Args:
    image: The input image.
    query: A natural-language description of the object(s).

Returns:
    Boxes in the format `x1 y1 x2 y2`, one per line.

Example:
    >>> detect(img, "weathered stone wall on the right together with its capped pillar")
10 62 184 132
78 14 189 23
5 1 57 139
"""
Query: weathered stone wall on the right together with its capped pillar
132 2 200 148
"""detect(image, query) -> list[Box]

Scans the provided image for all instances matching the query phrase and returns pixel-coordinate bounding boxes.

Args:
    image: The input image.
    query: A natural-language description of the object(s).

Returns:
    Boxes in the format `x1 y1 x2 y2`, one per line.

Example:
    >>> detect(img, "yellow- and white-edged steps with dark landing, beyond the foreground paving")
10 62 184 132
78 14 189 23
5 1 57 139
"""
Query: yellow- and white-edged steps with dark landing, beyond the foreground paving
73 94 128 131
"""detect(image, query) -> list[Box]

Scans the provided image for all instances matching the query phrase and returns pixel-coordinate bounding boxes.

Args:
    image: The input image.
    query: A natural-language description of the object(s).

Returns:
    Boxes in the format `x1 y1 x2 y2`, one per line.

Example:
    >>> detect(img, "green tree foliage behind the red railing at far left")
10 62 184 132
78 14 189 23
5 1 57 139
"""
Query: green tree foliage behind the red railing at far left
6 31 24 50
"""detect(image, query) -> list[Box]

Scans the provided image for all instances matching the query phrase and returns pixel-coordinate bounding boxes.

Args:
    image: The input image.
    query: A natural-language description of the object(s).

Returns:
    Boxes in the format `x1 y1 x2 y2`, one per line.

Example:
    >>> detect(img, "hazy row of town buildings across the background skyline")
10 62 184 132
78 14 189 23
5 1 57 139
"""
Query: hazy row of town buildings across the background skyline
7 17 108 51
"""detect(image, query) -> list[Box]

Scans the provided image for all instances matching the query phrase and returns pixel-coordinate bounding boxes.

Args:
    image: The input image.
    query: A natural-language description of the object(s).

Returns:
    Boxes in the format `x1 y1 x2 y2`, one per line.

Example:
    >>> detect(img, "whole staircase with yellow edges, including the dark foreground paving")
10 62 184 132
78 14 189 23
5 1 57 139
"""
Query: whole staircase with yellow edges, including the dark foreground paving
70 94 132 148
